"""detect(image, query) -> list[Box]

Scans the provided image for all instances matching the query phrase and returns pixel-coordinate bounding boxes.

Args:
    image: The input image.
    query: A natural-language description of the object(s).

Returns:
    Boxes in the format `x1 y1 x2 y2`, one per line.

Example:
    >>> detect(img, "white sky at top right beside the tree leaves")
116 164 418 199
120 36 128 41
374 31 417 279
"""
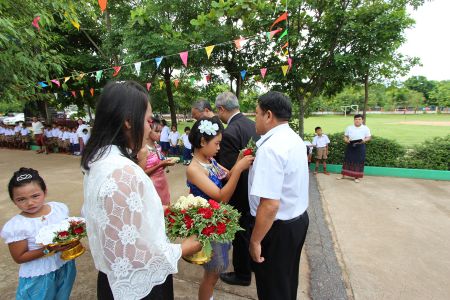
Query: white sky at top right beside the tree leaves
400 0 450 80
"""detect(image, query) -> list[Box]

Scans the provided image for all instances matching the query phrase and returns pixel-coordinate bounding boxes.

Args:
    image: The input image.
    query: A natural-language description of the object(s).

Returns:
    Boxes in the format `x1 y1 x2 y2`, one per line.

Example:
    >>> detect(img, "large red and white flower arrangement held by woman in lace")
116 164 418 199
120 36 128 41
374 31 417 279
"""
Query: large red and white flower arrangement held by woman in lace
164 195 243 262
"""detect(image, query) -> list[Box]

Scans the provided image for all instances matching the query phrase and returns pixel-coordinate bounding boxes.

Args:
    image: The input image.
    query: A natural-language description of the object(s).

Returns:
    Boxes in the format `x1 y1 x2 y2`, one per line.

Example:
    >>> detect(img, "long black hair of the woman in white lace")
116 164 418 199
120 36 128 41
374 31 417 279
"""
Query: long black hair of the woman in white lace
81 81 149 170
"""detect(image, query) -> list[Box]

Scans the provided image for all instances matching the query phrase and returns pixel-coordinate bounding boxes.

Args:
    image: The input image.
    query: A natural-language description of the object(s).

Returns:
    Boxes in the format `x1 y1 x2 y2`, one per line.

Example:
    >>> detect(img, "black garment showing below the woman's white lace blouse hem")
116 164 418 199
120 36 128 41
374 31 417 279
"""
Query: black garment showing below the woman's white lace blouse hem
97 272 173 300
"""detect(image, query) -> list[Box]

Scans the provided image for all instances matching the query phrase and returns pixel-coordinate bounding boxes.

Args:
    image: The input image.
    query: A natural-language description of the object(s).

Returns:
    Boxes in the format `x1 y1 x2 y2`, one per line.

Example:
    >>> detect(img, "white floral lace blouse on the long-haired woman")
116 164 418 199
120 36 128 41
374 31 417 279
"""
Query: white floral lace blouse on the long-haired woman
82 146 181 300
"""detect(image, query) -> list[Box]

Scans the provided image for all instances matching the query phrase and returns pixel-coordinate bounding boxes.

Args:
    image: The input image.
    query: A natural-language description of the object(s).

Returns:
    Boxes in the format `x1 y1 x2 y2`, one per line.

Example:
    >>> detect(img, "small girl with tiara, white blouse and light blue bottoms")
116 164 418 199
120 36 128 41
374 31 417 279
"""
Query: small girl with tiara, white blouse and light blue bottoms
0 168 77 300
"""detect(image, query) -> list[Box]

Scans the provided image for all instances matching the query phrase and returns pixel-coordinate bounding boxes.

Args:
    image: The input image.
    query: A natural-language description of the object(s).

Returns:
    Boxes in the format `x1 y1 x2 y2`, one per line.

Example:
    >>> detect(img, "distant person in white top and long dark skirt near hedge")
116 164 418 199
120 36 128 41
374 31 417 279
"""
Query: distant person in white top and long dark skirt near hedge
337 114 372 183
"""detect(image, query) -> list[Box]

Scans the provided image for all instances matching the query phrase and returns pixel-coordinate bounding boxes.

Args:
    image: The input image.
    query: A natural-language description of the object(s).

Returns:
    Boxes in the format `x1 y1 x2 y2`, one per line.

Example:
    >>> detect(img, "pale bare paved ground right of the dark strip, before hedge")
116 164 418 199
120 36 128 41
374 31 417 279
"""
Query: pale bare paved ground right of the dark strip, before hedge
316 174 450 300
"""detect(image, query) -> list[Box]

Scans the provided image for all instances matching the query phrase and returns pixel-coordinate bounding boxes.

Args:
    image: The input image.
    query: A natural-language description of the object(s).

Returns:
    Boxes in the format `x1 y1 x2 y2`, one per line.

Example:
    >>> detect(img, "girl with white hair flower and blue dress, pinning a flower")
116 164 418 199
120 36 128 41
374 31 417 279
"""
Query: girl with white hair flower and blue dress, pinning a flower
186 118 254 300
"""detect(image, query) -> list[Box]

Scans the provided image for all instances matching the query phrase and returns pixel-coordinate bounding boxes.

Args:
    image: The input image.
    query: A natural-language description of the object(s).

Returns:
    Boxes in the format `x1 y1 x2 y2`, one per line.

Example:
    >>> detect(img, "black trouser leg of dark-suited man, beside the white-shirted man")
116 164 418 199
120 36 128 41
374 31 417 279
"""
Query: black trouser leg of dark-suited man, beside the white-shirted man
233 213 252 280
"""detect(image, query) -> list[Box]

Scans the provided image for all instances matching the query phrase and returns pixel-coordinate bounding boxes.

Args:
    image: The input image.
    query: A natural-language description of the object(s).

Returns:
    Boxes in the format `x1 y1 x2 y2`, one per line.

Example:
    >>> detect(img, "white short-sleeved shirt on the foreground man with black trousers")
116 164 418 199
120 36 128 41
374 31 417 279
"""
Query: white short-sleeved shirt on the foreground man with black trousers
248 124 309 220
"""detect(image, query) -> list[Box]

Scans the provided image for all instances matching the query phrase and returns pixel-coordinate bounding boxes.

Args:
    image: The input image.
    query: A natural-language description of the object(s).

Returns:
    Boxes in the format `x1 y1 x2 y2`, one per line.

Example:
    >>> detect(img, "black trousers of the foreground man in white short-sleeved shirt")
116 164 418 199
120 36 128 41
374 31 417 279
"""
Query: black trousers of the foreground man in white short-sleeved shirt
252 211 309 300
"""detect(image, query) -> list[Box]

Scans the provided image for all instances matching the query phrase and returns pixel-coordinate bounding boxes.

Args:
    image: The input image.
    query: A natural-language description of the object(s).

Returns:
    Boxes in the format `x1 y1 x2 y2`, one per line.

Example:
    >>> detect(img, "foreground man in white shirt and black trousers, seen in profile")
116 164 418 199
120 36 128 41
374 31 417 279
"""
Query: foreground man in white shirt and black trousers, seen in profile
249 92 309 300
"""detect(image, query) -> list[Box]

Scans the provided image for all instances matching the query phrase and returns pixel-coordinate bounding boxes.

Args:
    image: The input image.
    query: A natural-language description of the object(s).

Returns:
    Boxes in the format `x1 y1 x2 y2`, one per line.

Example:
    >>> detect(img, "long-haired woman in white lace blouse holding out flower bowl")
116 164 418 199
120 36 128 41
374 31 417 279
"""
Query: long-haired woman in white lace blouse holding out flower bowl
81 81 201 300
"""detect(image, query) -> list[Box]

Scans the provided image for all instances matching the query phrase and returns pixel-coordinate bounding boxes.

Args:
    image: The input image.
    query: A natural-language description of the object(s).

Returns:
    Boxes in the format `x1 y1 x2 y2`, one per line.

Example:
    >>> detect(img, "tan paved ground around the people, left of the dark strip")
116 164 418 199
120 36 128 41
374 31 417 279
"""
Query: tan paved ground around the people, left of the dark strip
0 149 309 300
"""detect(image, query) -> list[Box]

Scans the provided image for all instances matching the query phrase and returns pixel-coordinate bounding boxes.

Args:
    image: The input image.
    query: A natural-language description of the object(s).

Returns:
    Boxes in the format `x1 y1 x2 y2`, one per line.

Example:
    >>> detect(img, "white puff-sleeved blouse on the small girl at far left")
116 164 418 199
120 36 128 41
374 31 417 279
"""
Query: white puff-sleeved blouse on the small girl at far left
1 202 69 277
